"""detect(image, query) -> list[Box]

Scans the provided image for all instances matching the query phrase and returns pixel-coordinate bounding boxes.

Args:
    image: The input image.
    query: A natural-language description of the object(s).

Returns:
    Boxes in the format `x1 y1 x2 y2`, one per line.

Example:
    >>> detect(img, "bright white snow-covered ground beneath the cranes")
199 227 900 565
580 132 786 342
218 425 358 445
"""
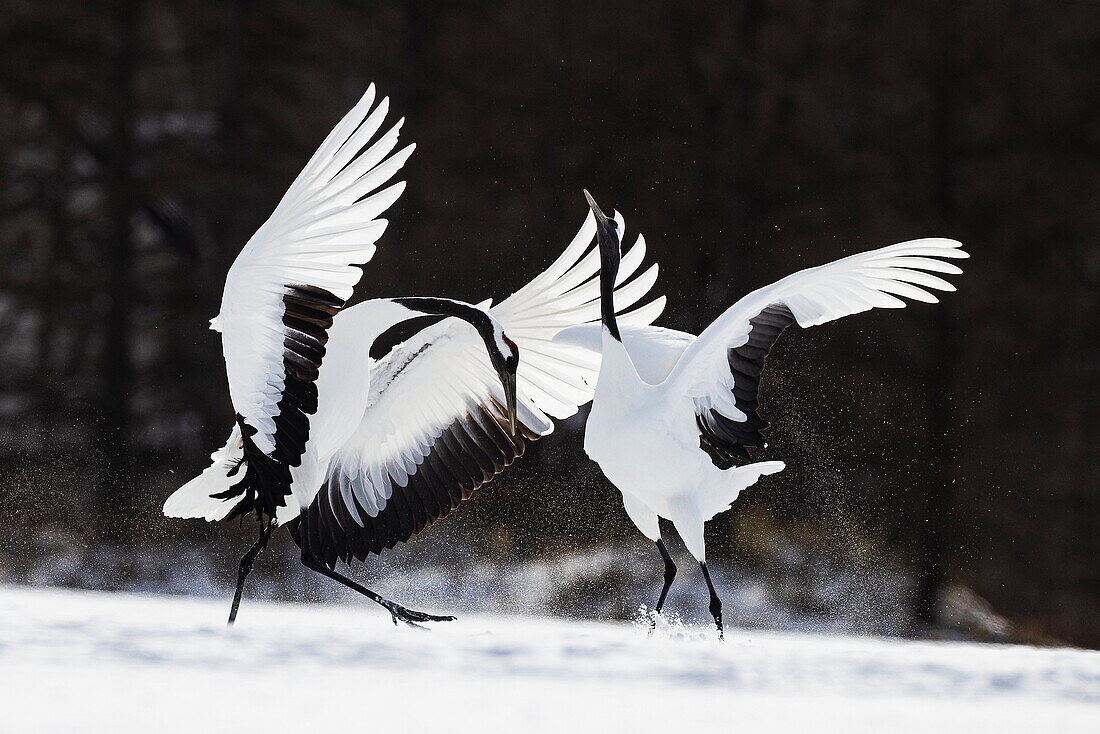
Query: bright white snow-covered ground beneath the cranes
0 587 1100 734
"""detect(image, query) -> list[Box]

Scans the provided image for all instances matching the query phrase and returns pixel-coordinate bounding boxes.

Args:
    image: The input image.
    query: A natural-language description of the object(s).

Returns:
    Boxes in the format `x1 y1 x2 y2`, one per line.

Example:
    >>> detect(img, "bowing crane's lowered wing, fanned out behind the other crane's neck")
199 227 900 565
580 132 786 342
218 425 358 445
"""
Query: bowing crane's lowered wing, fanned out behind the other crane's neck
292 215 664 563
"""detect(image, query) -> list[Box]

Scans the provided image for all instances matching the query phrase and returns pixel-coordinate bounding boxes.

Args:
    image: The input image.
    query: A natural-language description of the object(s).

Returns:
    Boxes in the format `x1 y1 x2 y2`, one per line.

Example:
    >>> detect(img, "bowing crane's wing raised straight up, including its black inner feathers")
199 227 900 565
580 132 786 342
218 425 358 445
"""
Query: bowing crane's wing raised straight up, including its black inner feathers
211 85 413 517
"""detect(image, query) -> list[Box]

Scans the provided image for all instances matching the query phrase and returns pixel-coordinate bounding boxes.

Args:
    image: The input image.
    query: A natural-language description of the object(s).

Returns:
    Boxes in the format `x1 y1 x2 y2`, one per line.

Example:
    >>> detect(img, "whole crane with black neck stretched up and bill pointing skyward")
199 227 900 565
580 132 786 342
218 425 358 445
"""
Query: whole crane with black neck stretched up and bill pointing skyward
556 191 968 637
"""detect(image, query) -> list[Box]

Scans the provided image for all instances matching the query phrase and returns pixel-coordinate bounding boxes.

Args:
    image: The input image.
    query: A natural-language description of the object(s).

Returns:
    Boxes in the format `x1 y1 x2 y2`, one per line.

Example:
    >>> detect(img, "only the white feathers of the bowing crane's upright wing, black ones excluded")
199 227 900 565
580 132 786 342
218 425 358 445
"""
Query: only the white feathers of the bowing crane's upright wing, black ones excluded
211 85 414 453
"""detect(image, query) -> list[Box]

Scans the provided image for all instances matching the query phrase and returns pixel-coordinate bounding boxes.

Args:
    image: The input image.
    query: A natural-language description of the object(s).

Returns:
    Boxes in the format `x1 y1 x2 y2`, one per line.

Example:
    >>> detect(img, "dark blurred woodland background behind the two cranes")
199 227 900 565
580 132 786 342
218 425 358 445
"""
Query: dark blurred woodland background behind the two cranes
0 0 1100 646
